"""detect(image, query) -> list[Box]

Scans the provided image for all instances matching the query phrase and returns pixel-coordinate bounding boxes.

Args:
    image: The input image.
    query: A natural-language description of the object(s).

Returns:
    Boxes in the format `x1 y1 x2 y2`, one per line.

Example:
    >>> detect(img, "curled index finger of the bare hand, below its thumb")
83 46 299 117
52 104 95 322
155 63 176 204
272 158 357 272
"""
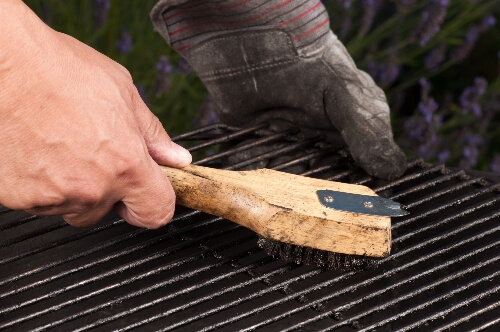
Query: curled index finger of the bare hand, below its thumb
115 158 175 229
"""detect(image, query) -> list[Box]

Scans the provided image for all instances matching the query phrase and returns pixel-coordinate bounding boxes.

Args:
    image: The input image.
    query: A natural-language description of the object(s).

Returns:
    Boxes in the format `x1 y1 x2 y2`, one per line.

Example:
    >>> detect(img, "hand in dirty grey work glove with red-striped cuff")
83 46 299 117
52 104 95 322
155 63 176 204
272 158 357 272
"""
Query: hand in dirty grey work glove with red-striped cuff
151 0 406 179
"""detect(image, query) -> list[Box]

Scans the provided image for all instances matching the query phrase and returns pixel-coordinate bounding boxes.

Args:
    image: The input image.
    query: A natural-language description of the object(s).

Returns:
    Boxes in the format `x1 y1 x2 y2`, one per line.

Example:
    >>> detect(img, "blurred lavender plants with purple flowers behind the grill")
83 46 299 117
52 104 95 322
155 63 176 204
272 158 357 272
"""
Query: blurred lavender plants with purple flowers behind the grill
25 0 500 173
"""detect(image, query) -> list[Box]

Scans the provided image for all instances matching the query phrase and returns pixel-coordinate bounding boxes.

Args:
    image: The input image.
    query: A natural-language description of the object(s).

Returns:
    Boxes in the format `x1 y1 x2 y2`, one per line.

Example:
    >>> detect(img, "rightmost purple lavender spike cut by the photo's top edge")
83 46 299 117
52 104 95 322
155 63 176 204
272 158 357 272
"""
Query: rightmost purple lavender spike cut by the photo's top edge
413 0 449 46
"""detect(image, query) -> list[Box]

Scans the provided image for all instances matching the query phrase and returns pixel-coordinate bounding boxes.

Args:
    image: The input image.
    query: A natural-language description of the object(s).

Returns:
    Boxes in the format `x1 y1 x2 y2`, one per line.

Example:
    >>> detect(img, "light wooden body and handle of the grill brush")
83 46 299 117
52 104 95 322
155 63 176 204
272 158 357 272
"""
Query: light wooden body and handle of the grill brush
162 165 391 257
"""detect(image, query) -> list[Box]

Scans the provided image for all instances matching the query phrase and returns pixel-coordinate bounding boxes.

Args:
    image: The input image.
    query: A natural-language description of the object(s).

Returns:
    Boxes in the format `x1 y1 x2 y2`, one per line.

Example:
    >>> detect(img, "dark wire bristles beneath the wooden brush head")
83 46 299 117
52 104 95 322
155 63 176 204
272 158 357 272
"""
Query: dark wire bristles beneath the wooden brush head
257 236 378 271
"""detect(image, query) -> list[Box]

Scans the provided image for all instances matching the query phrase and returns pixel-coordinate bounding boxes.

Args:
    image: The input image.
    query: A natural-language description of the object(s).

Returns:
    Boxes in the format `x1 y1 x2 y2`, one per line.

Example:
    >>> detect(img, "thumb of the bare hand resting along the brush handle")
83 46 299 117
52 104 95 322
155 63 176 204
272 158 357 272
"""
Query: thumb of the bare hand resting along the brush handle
134 88 192 167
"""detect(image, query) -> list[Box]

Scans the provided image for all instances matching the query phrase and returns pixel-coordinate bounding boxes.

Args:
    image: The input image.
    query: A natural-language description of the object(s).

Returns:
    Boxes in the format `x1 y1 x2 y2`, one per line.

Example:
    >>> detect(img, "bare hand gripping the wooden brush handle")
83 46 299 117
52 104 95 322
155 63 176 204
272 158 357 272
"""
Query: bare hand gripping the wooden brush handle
0 0 191 228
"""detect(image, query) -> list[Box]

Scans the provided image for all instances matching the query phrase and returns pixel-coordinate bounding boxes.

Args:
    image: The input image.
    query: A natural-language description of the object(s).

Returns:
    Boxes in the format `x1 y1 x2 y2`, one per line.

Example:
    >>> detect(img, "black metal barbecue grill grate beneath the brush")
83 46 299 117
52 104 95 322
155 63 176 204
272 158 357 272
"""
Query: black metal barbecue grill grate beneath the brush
0 124 500 331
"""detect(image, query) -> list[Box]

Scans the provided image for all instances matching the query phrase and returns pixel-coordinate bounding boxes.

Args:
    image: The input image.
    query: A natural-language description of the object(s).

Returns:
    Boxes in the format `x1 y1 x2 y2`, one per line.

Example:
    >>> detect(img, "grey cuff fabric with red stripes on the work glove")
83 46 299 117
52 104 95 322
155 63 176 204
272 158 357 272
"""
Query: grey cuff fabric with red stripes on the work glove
163 0 330 51
